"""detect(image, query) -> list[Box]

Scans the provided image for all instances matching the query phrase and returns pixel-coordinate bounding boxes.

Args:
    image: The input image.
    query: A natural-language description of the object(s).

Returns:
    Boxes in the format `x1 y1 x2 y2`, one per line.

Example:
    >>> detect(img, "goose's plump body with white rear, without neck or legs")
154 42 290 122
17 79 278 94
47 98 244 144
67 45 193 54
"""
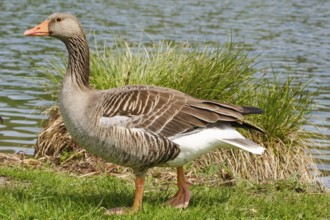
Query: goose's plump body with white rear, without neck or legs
60 80 264 175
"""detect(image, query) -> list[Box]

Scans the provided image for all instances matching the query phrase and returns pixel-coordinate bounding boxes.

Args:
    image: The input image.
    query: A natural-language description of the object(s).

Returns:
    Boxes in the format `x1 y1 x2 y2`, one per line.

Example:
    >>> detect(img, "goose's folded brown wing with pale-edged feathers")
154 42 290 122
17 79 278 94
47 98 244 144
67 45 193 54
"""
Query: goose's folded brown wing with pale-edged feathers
103 86 259 137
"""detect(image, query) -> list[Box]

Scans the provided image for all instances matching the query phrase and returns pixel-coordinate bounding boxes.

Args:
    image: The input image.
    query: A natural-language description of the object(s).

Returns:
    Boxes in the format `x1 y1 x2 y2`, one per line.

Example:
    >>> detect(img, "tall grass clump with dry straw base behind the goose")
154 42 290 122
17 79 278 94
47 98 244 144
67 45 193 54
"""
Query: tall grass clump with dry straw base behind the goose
36 40 316 184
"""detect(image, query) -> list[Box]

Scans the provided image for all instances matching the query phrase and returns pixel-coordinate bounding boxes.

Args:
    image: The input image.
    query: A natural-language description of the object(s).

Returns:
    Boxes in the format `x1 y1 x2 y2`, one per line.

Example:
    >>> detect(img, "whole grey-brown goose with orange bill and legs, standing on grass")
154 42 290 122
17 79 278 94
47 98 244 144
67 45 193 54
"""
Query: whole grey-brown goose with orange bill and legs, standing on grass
24 13 264 214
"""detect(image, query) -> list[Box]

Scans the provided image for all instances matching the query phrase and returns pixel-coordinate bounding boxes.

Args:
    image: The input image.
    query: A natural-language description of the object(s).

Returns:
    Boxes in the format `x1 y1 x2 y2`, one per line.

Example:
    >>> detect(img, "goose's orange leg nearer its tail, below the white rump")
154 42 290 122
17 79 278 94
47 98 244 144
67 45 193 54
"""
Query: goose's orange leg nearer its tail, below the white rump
167 166 191 208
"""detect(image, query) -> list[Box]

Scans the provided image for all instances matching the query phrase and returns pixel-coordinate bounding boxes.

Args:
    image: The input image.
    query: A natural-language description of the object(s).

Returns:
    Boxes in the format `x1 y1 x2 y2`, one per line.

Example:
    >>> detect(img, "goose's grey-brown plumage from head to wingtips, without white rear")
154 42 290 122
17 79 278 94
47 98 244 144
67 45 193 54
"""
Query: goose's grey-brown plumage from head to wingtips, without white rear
25 13 262 179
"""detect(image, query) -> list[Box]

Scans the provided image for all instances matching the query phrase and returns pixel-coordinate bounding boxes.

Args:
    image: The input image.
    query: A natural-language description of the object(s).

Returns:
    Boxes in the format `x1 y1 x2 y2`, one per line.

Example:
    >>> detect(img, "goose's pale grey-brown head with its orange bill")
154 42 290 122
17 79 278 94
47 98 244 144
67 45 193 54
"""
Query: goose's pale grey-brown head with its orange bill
24 13 84 42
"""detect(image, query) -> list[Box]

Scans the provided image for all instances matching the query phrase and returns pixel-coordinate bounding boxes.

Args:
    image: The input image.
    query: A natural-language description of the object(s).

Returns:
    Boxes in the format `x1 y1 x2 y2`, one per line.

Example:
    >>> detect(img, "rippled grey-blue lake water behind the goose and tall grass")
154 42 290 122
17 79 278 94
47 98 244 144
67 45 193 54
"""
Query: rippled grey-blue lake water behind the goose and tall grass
0 0 330 186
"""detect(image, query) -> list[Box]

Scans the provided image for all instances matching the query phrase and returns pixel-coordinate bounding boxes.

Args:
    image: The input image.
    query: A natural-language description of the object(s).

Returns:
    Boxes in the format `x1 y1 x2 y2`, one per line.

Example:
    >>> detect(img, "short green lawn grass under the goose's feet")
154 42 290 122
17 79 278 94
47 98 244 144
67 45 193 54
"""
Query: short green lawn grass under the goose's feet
0 166 330 219
